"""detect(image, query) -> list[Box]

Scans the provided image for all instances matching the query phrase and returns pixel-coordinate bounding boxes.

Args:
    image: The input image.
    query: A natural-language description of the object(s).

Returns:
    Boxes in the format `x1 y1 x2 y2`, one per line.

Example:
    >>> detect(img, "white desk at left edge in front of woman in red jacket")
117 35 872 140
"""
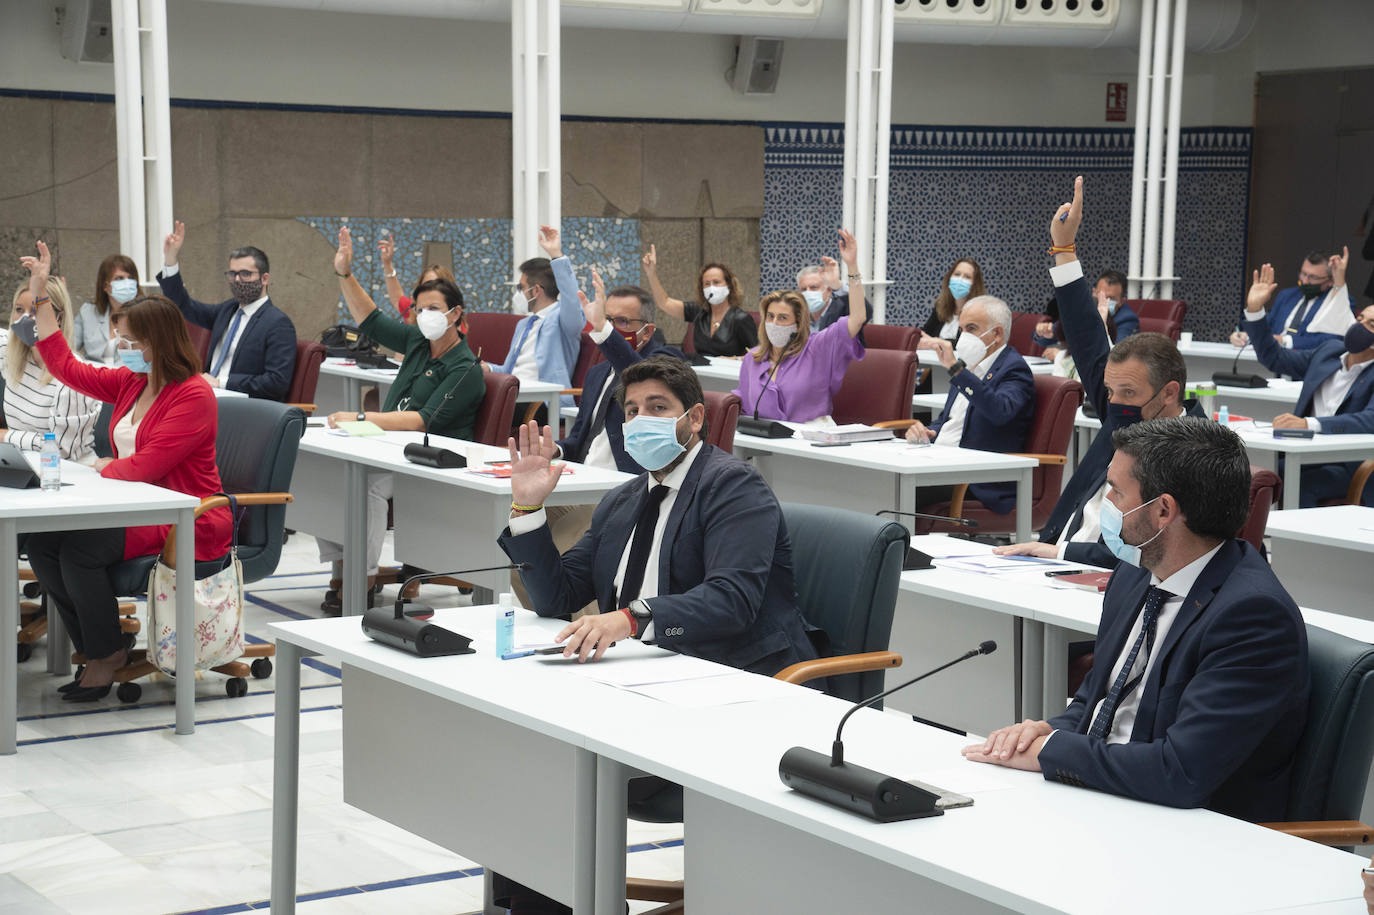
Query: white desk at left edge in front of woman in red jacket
0 453 201 754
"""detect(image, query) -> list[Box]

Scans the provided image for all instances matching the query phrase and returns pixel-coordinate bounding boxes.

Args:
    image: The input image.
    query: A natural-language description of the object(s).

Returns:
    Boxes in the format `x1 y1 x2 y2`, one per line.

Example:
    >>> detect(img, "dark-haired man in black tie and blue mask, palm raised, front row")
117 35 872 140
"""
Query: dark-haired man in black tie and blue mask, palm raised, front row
493 356 816 914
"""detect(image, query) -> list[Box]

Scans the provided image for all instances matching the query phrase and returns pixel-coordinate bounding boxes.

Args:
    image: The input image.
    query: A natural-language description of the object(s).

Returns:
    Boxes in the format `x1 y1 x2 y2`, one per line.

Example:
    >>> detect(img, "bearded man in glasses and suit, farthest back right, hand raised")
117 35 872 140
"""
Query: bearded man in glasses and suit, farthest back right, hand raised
1231 249 1351 349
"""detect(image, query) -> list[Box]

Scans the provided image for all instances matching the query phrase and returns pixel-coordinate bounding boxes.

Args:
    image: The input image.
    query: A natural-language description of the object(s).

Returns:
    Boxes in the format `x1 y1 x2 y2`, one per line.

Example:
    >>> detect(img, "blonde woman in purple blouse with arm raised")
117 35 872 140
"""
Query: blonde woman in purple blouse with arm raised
734 229 866 423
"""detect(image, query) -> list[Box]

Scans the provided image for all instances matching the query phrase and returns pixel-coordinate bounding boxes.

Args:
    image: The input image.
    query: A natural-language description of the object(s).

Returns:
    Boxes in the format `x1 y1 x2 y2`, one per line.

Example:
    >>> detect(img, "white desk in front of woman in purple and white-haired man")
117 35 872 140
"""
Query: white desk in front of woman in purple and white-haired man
735 433 1036 541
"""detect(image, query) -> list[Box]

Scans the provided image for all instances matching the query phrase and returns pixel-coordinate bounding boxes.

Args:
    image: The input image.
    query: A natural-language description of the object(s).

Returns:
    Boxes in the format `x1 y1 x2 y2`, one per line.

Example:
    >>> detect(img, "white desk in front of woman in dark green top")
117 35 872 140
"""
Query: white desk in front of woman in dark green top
286 429 632 613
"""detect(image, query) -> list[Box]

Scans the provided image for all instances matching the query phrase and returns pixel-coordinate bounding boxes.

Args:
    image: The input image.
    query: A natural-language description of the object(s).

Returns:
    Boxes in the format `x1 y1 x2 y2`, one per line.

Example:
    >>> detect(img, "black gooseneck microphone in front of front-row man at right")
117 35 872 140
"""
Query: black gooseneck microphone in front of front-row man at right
778 642 998 823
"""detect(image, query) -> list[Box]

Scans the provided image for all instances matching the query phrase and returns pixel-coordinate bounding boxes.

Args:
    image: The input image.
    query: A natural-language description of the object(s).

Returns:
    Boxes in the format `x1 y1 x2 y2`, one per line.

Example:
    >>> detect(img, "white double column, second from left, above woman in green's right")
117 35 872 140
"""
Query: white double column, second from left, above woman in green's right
511 0 562 272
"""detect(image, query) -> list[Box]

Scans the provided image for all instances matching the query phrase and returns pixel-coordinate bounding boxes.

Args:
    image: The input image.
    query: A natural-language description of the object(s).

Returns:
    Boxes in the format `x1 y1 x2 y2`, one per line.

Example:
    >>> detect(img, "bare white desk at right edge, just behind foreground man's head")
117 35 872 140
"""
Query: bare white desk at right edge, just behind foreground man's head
1264 506 1374 620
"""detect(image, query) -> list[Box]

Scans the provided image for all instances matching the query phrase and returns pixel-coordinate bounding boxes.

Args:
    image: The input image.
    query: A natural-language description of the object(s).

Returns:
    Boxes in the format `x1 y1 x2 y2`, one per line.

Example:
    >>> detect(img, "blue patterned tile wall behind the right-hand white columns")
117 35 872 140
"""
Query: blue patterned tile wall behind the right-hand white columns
761 124 1250 339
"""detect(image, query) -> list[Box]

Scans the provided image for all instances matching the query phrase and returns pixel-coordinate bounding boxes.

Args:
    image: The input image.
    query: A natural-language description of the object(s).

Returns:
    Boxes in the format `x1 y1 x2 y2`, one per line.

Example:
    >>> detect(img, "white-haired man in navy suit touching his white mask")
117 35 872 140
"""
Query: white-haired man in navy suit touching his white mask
907 295 1035 515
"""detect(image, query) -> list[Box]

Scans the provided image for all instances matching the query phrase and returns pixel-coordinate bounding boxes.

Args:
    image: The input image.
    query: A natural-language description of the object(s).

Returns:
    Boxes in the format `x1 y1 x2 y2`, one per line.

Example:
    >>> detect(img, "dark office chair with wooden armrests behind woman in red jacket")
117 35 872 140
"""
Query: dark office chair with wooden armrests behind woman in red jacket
92 397 305 702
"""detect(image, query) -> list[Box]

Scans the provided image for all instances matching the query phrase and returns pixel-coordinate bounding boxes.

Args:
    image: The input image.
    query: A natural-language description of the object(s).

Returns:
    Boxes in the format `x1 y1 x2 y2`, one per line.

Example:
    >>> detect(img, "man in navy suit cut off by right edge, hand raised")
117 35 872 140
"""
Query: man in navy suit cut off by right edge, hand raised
1245 264 1374 508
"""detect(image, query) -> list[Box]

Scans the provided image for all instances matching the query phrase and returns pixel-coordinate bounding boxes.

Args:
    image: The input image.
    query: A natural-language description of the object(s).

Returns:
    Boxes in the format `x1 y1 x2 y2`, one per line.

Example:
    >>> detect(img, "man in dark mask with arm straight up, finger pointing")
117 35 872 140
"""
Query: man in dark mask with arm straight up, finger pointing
998 177 1204 569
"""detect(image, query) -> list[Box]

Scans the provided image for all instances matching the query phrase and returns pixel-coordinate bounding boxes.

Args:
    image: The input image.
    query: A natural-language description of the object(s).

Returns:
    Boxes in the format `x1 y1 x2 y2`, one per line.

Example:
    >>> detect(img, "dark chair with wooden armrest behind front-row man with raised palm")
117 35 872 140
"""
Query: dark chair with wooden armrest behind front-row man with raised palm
627 503 911 912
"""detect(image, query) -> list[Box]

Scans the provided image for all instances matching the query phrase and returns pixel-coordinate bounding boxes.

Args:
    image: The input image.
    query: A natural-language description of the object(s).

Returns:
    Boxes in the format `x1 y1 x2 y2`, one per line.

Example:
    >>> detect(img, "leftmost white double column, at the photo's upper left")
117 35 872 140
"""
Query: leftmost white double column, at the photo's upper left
110 0 148 278
